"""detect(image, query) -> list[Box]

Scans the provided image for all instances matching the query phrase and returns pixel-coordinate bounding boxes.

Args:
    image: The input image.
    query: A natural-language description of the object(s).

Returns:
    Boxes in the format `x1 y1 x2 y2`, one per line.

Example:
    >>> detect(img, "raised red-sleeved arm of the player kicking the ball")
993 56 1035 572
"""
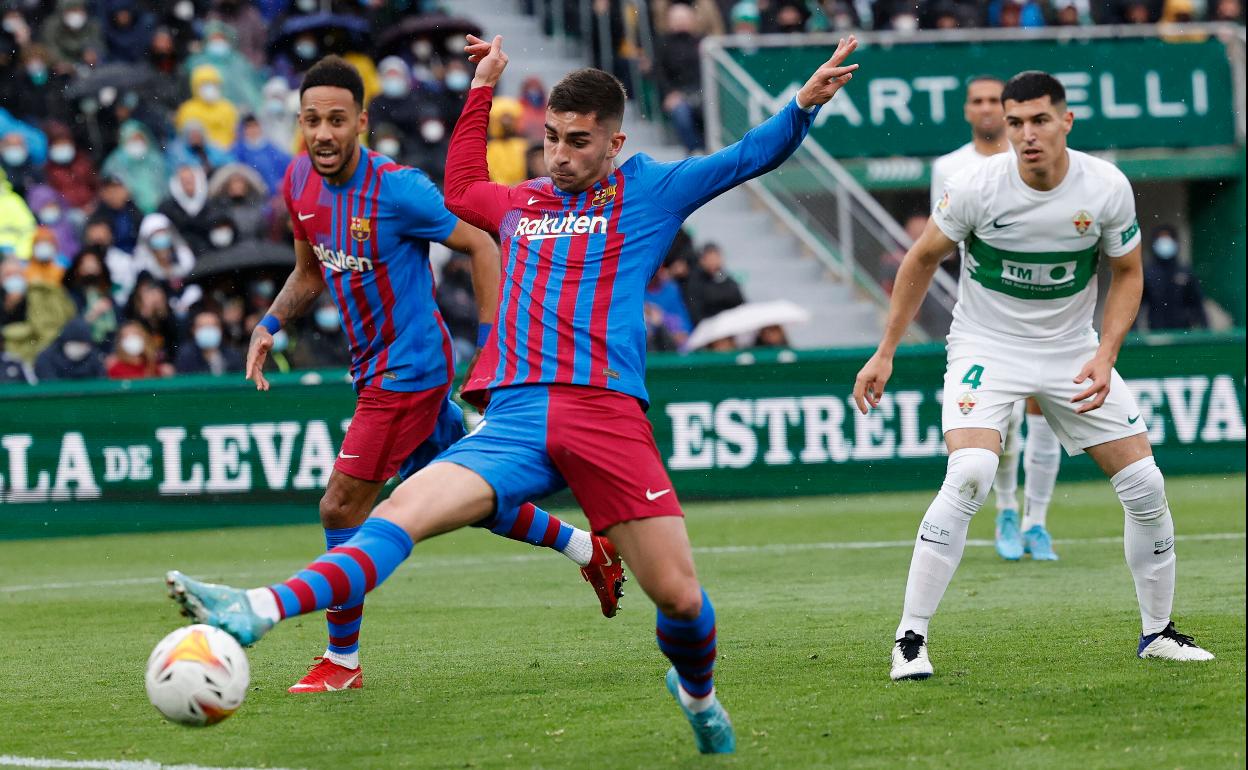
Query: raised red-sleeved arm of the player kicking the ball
444 35 512 232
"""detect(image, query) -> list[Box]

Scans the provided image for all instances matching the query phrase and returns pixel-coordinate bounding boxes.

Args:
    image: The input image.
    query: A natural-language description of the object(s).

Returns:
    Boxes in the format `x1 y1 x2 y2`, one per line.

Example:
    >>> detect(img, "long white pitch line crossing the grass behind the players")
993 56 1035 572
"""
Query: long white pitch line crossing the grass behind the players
0 532 1244 594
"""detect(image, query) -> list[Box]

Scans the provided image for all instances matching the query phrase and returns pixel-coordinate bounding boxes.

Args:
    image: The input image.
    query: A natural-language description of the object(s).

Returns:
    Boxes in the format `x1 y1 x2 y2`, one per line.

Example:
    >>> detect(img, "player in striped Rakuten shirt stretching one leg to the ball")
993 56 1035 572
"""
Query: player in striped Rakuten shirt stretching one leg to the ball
168 36 857 753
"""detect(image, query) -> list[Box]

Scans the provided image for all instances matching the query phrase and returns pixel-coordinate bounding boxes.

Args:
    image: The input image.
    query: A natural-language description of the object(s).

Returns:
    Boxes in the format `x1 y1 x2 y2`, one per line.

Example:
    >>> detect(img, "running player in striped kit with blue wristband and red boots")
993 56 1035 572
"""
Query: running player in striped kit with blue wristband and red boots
233 56 624 693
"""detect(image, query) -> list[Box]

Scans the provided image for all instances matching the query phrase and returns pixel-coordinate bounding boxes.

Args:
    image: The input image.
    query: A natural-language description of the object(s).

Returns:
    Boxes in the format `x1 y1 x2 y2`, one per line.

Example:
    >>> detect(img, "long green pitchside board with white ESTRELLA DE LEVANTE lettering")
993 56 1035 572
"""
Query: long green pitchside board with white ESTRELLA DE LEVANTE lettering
0 334 1244 539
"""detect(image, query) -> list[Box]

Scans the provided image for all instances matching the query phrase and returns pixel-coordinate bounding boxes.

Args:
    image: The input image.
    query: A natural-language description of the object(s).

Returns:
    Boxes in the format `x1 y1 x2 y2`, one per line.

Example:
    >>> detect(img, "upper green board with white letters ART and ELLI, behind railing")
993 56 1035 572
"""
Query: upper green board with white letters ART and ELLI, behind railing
708 35 1237 157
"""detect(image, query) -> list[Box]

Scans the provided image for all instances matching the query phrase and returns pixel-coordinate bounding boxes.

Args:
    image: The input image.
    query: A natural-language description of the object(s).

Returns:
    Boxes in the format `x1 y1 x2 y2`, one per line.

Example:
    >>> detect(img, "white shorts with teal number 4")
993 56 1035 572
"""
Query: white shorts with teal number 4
941 336 1148 456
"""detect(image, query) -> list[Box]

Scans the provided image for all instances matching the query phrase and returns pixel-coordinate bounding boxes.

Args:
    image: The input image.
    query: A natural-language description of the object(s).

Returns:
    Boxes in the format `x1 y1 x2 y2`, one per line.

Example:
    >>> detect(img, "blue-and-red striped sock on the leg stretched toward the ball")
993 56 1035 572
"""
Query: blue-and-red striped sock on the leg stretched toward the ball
268 518 412 618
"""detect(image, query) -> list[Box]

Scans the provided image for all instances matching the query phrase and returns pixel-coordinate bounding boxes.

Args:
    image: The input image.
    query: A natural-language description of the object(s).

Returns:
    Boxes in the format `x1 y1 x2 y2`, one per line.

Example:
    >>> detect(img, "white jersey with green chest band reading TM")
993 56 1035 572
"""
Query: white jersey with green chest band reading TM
932 150 1139 342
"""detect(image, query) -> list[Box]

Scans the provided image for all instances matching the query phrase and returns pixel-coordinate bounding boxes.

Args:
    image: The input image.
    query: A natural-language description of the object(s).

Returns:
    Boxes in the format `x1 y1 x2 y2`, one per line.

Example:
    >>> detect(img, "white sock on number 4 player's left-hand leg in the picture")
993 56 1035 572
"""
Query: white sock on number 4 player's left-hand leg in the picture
894 448 997 639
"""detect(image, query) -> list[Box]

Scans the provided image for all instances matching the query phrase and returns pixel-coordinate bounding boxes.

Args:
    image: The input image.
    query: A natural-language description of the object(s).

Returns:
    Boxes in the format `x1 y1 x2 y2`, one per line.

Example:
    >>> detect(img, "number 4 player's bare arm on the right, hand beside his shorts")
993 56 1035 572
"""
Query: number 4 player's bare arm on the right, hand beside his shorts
1071 246 1144 414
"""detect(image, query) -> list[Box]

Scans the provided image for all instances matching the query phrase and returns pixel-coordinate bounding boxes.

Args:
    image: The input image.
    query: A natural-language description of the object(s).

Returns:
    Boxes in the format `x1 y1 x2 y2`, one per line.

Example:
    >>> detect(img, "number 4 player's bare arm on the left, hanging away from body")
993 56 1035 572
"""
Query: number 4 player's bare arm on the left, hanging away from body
854 221 957 414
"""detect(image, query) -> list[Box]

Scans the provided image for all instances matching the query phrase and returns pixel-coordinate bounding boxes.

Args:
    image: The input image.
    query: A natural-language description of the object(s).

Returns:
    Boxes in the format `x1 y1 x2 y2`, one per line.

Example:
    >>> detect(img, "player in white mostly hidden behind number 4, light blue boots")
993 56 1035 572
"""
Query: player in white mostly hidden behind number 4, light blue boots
929 75 1062 562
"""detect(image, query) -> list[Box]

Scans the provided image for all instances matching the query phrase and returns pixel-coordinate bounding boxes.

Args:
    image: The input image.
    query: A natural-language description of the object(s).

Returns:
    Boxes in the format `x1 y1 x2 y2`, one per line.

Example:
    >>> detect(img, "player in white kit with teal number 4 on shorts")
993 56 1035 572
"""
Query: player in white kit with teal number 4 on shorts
854 71 1213 679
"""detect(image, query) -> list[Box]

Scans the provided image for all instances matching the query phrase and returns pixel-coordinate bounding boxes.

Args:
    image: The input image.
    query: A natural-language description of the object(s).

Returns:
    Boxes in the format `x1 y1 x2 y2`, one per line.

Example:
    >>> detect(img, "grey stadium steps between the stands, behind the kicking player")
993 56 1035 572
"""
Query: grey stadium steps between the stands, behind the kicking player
454 0 882 347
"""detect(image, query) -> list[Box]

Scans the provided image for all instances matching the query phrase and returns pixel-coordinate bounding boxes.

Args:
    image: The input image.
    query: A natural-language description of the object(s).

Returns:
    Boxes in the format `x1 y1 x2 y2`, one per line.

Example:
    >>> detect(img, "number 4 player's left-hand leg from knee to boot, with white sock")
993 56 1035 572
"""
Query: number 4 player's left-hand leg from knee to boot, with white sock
891 428 1001 679
